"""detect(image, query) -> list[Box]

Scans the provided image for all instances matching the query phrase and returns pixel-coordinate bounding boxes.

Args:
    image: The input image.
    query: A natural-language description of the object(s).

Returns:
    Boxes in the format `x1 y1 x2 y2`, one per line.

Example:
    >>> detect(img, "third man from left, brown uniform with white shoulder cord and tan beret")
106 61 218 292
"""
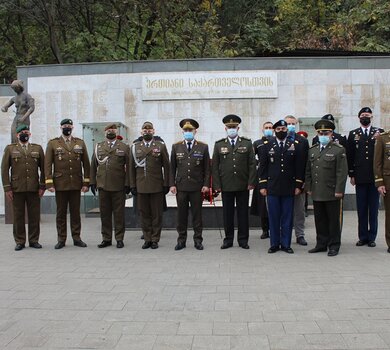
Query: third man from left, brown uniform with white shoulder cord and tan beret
90 123 130 248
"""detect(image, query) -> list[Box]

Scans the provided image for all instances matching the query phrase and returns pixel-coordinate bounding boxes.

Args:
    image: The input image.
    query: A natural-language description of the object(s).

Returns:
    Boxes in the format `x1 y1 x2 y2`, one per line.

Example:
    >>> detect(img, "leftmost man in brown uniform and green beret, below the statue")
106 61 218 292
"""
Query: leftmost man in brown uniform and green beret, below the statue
1 124 45 250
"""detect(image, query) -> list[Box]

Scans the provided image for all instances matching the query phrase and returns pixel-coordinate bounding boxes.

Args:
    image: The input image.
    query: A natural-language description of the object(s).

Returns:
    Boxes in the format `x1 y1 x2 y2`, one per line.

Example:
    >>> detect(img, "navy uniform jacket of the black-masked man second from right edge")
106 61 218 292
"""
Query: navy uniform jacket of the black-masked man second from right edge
347 126 383 184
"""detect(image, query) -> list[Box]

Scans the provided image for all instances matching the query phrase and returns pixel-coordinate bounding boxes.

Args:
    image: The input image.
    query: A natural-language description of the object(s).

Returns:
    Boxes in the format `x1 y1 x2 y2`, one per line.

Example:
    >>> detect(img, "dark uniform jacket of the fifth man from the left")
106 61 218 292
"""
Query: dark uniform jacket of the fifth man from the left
169 140 210 191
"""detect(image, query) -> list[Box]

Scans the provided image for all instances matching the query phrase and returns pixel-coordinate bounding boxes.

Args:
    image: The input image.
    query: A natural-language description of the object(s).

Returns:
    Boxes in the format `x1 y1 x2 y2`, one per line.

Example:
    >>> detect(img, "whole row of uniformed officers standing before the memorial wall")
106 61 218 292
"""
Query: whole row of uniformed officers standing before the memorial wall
1 107 390 256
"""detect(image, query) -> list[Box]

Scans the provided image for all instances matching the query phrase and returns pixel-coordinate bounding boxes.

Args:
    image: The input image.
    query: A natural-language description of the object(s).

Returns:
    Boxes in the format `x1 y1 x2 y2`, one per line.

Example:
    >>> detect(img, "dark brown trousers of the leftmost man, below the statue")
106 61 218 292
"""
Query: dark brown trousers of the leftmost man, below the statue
12 191 41 244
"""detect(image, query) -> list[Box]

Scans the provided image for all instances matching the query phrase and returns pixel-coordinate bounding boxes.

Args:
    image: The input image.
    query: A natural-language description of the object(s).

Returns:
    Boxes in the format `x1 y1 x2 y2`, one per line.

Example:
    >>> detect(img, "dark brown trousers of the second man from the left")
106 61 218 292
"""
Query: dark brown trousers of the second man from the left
56 190 81 242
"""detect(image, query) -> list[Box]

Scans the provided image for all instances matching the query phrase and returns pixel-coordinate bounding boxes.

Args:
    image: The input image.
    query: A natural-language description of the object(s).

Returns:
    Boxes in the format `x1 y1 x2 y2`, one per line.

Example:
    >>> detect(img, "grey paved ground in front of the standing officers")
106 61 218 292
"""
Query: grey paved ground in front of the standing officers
0 212 390 350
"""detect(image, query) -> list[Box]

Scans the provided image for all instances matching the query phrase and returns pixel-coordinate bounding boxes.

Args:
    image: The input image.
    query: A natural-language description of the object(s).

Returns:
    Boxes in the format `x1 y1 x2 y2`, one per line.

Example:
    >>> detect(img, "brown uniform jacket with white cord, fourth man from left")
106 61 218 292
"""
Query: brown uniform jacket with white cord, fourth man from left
130 139 169 193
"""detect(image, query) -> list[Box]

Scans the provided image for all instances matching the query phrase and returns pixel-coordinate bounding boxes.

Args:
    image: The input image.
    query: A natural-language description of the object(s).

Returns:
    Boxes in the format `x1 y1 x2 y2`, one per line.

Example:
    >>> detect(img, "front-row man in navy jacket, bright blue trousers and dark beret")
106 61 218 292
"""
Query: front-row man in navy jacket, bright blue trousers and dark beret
258 120 305 254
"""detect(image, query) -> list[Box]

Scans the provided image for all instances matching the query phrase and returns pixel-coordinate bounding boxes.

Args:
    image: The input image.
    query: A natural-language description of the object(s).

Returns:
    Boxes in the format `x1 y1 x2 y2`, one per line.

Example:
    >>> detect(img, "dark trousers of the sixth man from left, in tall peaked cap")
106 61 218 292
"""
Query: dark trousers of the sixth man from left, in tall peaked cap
222 191 249 245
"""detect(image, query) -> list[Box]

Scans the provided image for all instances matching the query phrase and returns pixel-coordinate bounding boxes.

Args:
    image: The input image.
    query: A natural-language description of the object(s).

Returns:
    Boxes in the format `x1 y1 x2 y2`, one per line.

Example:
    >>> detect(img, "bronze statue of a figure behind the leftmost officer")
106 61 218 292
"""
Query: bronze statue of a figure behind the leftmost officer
1 80 35 143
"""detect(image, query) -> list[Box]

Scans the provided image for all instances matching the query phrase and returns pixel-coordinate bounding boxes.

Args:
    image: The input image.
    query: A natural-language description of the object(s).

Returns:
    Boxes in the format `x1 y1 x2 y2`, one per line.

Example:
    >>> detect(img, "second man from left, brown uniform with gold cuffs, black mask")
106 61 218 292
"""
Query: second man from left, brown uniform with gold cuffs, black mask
45 119 90 249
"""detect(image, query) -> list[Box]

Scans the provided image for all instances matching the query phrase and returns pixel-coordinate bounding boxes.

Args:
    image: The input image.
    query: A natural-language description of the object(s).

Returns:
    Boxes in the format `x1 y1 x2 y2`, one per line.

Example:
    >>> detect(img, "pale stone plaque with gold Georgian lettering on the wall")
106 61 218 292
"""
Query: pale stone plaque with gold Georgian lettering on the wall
142 70 278 100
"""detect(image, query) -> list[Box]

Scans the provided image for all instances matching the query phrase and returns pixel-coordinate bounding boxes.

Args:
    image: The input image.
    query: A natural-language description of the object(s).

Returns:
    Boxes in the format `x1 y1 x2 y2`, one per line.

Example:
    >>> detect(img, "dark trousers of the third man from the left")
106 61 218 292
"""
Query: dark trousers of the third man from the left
99 188 126 242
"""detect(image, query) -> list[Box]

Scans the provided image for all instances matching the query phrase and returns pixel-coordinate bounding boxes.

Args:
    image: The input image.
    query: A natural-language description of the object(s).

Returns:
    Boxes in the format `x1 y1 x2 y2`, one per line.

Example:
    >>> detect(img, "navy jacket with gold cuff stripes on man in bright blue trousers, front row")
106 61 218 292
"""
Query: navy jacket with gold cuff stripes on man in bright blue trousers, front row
258 137 305 196
